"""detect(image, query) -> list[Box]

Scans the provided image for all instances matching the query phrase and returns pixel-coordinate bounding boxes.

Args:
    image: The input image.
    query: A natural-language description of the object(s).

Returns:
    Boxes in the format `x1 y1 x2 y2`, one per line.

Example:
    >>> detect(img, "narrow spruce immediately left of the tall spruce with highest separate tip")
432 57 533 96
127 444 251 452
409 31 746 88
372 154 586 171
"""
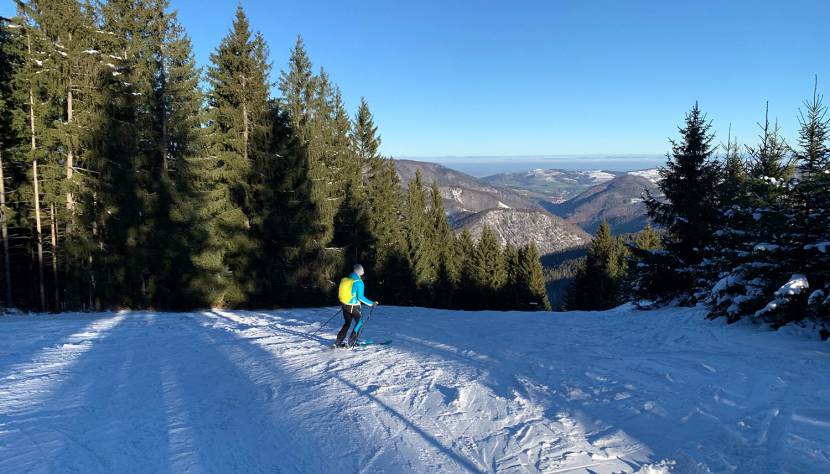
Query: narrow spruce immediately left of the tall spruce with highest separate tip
155 15 214 309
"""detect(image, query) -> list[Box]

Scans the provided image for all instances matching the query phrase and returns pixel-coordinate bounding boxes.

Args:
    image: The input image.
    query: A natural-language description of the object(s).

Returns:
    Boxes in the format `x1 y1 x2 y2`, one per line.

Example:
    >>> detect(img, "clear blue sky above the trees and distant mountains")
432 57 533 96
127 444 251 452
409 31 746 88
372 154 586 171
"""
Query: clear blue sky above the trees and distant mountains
0 0 830 157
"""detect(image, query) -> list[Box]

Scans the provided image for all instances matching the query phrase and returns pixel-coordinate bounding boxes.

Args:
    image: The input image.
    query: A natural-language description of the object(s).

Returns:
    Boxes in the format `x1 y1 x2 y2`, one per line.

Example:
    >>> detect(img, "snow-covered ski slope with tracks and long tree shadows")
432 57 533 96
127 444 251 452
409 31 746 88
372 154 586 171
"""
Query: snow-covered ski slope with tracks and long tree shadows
0 307 830 473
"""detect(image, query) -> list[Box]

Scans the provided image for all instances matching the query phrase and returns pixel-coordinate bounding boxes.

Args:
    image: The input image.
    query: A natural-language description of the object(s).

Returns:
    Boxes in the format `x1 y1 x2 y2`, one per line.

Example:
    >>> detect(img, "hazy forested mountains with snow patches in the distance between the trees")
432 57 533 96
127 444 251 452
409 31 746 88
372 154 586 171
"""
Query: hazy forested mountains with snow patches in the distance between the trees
395 160 659 256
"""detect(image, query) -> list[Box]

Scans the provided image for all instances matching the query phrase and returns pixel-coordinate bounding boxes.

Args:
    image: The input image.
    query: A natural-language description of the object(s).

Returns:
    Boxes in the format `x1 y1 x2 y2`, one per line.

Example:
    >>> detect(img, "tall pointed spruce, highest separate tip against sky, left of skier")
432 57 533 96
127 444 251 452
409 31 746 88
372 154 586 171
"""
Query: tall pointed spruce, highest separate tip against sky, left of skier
202 7 272 305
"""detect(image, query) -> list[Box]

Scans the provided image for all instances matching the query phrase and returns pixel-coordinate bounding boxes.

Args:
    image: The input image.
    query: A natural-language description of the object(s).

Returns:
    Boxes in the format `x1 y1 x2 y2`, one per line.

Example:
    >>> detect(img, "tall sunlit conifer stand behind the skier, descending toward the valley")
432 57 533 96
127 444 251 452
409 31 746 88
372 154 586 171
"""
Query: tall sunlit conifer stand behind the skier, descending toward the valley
0 0 549 311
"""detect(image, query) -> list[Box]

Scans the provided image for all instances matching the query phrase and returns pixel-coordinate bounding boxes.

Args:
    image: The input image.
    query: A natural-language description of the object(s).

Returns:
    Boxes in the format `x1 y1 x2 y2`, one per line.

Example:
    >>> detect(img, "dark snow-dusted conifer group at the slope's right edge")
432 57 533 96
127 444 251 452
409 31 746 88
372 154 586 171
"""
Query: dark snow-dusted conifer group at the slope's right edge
569 92 830 338
